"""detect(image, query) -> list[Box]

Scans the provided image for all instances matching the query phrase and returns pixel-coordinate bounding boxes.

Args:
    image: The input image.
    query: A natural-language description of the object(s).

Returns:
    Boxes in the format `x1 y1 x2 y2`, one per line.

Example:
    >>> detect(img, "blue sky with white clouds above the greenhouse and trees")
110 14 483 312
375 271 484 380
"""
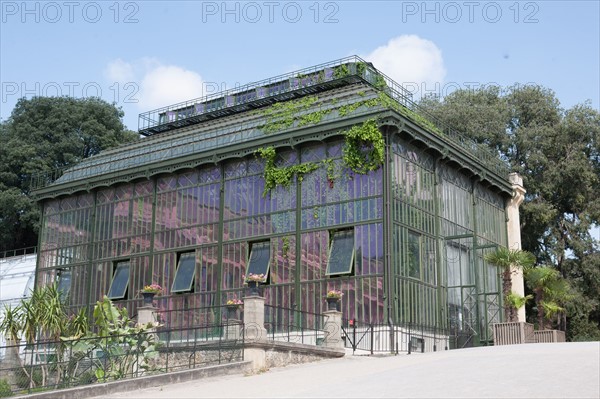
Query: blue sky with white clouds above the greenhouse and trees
0 1 600 130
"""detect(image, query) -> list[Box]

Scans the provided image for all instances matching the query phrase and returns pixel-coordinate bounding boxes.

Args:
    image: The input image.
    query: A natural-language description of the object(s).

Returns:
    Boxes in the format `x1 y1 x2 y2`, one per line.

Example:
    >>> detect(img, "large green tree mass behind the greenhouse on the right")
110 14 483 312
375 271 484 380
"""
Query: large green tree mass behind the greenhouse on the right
420 85 600 339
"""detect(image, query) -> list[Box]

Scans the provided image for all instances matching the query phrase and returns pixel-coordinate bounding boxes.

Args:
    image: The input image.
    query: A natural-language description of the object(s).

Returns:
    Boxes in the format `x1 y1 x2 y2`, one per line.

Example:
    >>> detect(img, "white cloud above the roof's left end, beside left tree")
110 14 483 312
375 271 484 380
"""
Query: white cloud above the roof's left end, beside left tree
104 57 205 111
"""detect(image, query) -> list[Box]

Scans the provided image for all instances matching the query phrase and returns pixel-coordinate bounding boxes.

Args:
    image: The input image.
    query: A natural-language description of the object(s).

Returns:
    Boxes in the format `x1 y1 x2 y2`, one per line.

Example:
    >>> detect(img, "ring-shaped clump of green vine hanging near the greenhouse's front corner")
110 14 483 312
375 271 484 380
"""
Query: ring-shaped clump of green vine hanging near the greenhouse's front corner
343 119 385 174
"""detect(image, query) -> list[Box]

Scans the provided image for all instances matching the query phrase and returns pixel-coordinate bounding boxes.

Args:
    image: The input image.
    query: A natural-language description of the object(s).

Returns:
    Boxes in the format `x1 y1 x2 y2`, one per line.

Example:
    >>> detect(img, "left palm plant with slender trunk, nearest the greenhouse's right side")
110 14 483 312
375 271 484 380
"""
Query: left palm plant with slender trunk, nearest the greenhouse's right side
484 247 535 322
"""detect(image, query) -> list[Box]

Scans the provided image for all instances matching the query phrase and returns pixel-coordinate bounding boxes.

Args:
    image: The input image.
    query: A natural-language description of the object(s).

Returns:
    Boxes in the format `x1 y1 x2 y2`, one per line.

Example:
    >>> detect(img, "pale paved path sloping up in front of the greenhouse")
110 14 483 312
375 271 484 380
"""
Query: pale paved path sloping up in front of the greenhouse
101 342 600 399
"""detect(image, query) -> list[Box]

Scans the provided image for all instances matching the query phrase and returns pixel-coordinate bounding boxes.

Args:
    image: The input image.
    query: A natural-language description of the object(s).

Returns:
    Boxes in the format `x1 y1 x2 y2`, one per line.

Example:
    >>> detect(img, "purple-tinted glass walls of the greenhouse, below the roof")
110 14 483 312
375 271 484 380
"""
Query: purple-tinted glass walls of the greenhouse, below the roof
32 71 509 343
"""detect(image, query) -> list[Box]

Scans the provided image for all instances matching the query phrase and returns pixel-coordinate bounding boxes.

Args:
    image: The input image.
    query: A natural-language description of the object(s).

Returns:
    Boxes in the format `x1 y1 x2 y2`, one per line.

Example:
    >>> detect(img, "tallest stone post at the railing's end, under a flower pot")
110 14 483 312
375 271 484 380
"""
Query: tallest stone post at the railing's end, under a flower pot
244 295 267 370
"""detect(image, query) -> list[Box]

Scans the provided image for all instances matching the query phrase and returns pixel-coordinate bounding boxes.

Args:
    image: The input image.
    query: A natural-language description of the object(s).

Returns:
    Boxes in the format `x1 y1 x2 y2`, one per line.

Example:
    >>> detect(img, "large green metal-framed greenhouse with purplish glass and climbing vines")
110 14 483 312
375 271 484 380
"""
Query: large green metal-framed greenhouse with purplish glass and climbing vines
34 57 520 345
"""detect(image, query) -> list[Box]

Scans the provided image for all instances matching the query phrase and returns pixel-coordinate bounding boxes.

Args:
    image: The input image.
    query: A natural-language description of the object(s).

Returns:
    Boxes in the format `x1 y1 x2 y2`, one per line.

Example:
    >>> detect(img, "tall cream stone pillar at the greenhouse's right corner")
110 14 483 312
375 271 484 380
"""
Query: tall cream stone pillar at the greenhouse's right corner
506 173 526 322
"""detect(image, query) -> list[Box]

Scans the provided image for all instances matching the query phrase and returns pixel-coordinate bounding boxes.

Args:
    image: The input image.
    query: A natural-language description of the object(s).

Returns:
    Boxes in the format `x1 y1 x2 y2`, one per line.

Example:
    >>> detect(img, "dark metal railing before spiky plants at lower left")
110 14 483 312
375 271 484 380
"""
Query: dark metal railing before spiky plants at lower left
0 322 244 397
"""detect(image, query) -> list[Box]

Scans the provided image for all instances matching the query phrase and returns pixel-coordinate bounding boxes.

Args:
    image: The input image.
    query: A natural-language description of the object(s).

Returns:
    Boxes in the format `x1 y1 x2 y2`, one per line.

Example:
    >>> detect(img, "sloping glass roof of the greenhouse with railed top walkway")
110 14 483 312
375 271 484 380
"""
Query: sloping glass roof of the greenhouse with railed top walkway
32 56 508 194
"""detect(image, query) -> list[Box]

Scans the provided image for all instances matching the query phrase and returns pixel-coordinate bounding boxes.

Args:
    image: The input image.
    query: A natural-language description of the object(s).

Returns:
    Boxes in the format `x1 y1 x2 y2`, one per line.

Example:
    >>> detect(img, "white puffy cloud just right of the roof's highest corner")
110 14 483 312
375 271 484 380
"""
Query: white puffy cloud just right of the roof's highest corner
363 35 446 93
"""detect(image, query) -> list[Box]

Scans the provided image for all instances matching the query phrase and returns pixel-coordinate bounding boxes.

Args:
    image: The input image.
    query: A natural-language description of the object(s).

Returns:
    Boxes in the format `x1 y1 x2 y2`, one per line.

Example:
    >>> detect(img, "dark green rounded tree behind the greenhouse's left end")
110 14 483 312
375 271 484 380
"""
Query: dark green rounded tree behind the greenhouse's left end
0 97 138 251
